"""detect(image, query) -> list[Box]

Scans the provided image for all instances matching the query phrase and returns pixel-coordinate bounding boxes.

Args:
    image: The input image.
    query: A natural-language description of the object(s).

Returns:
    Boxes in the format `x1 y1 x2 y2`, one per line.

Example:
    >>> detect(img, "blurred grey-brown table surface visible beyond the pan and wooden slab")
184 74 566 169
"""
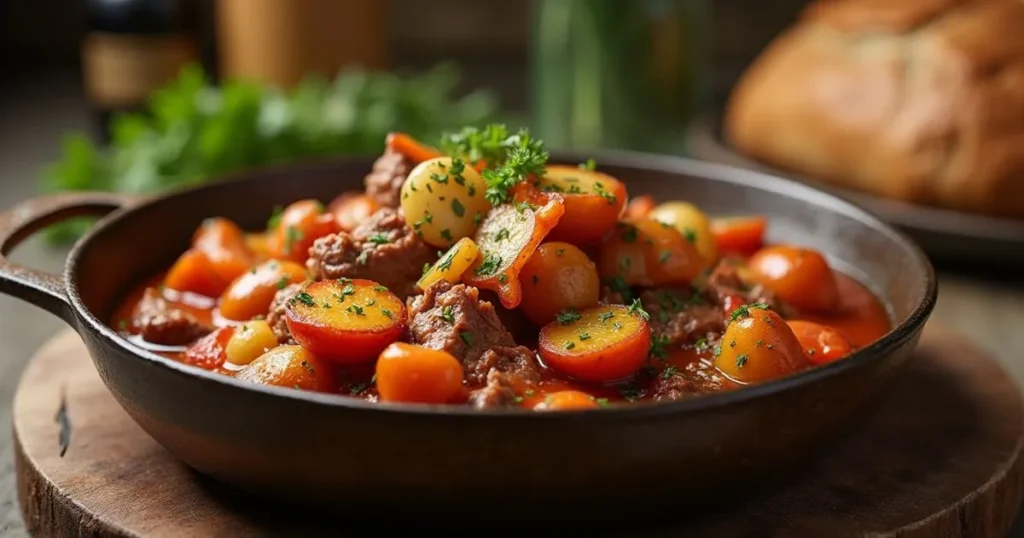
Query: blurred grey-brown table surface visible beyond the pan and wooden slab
0 73 1024 538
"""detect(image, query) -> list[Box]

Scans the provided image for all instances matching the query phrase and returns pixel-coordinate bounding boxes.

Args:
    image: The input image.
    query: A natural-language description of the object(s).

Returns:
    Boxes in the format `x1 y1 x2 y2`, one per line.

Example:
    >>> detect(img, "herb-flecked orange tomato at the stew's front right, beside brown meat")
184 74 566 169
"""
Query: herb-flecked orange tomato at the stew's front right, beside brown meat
715 304 809 383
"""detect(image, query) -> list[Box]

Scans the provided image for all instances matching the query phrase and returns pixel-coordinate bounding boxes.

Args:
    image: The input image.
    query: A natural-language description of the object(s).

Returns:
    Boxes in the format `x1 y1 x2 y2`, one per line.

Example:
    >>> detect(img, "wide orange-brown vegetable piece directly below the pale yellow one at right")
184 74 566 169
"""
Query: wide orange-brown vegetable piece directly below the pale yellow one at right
598 218 706 286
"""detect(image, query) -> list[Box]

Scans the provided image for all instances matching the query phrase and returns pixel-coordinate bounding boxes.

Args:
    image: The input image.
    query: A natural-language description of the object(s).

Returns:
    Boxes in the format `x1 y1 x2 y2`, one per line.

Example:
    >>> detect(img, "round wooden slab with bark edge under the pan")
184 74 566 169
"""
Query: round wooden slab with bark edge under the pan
13 327 1024 537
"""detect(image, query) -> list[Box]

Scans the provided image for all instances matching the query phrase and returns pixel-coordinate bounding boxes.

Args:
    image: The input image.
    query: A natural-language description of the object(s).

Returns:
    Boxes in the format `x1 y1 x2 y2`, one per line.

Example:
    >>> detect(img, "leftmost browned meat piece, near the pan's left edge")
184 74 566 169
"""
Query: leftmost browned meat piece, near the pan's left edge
131 288 213 345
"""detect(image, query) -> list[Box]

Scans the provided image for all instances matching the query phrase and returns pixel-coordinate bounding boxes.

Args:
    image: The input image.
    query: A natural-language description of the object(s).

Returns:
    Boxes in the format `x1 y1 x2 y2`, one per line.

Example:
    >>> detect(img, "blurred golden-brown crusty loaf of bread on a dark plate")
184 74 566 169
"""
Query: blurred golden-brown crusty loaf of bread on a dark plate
723 0 1024 218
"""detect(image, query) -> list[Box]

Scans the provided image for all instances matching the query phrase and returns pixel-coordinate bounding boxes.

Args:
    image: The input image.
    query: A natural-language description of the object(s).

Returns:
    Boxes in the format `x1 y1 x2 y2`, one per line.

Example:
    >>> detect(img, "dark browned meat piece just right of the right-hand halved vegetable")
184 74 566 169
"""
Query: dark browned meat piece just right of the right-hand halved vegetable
640 287 726 346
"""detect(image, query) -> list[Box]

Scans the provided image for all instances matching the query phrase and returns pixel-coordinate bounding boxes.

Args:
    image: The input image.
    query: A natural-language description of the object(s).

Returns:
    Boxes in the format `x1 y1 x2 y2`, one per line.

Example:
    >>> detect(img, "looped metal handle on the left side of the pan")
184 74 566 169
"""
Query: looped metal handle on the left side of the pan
0 192 139 322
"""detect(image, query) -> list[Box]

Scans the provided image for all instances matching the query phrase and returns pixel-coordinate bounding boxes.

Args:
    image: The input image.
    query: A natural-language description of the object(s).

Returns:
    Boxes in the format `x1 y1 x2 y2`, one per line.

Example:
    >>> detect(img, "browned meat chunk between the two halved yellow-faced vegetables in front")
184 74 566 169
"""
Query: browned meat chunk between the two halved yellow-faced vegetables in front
409 281 541 385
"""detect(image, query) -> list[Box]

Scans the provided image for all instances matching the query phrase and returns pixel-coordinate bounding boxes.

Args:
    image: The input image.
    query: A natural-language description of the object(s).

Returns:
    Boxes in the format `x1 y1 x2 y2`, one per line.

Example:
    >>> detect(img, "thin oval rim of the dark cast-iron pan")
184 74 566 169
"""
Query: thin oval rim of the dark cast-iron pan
65 151 937 421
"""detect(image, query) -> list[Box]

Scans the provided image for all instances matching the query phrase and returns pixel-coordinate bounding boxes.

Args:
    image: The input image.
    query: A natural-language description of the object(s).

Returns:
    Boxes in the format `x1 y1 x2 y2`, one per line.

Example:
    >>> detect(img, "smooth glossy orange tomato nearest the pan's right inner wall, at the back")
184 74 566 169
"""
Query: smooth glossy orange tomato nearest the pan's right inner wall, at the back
748 245 839 312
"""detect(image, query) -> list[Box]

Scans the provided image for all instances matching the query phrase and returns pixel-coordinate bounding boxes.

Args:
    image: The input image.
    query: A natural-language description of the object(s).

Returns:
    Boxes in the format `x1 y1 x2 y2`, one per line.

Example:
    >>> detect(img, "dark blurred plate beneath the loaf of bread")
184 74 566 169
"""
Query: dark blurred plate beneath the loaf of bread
687 113 1024 241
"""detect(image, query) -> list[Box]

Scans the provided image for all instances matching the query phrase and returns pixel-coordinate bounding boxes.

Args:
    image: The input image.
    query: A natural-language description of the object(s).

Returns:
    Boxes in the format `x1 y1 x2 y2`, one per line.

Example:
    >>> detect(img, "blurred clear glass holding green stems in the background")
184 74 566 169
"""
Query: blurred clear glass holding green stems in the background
531 0 711 153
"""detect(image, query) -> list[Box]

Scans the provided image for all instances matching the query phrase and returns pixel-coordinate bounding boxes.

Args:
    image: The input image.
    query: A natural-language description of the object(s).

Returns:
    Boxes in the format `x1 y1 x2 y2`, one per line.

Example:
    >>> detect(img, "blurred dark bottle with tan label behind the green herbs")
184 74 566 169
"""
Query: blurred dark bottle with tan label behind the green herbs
82 0 212 142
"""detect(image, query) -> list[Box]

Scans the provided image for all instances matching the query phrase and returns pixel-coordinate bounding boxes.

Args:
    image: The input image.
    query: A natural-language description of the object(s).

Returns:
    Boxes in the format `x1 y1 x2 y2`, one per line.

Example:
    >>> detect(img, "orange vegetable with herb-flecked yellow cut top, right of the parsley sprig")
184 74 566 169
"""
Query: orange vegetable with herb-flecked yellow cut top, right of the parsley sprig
532 165 627 244
